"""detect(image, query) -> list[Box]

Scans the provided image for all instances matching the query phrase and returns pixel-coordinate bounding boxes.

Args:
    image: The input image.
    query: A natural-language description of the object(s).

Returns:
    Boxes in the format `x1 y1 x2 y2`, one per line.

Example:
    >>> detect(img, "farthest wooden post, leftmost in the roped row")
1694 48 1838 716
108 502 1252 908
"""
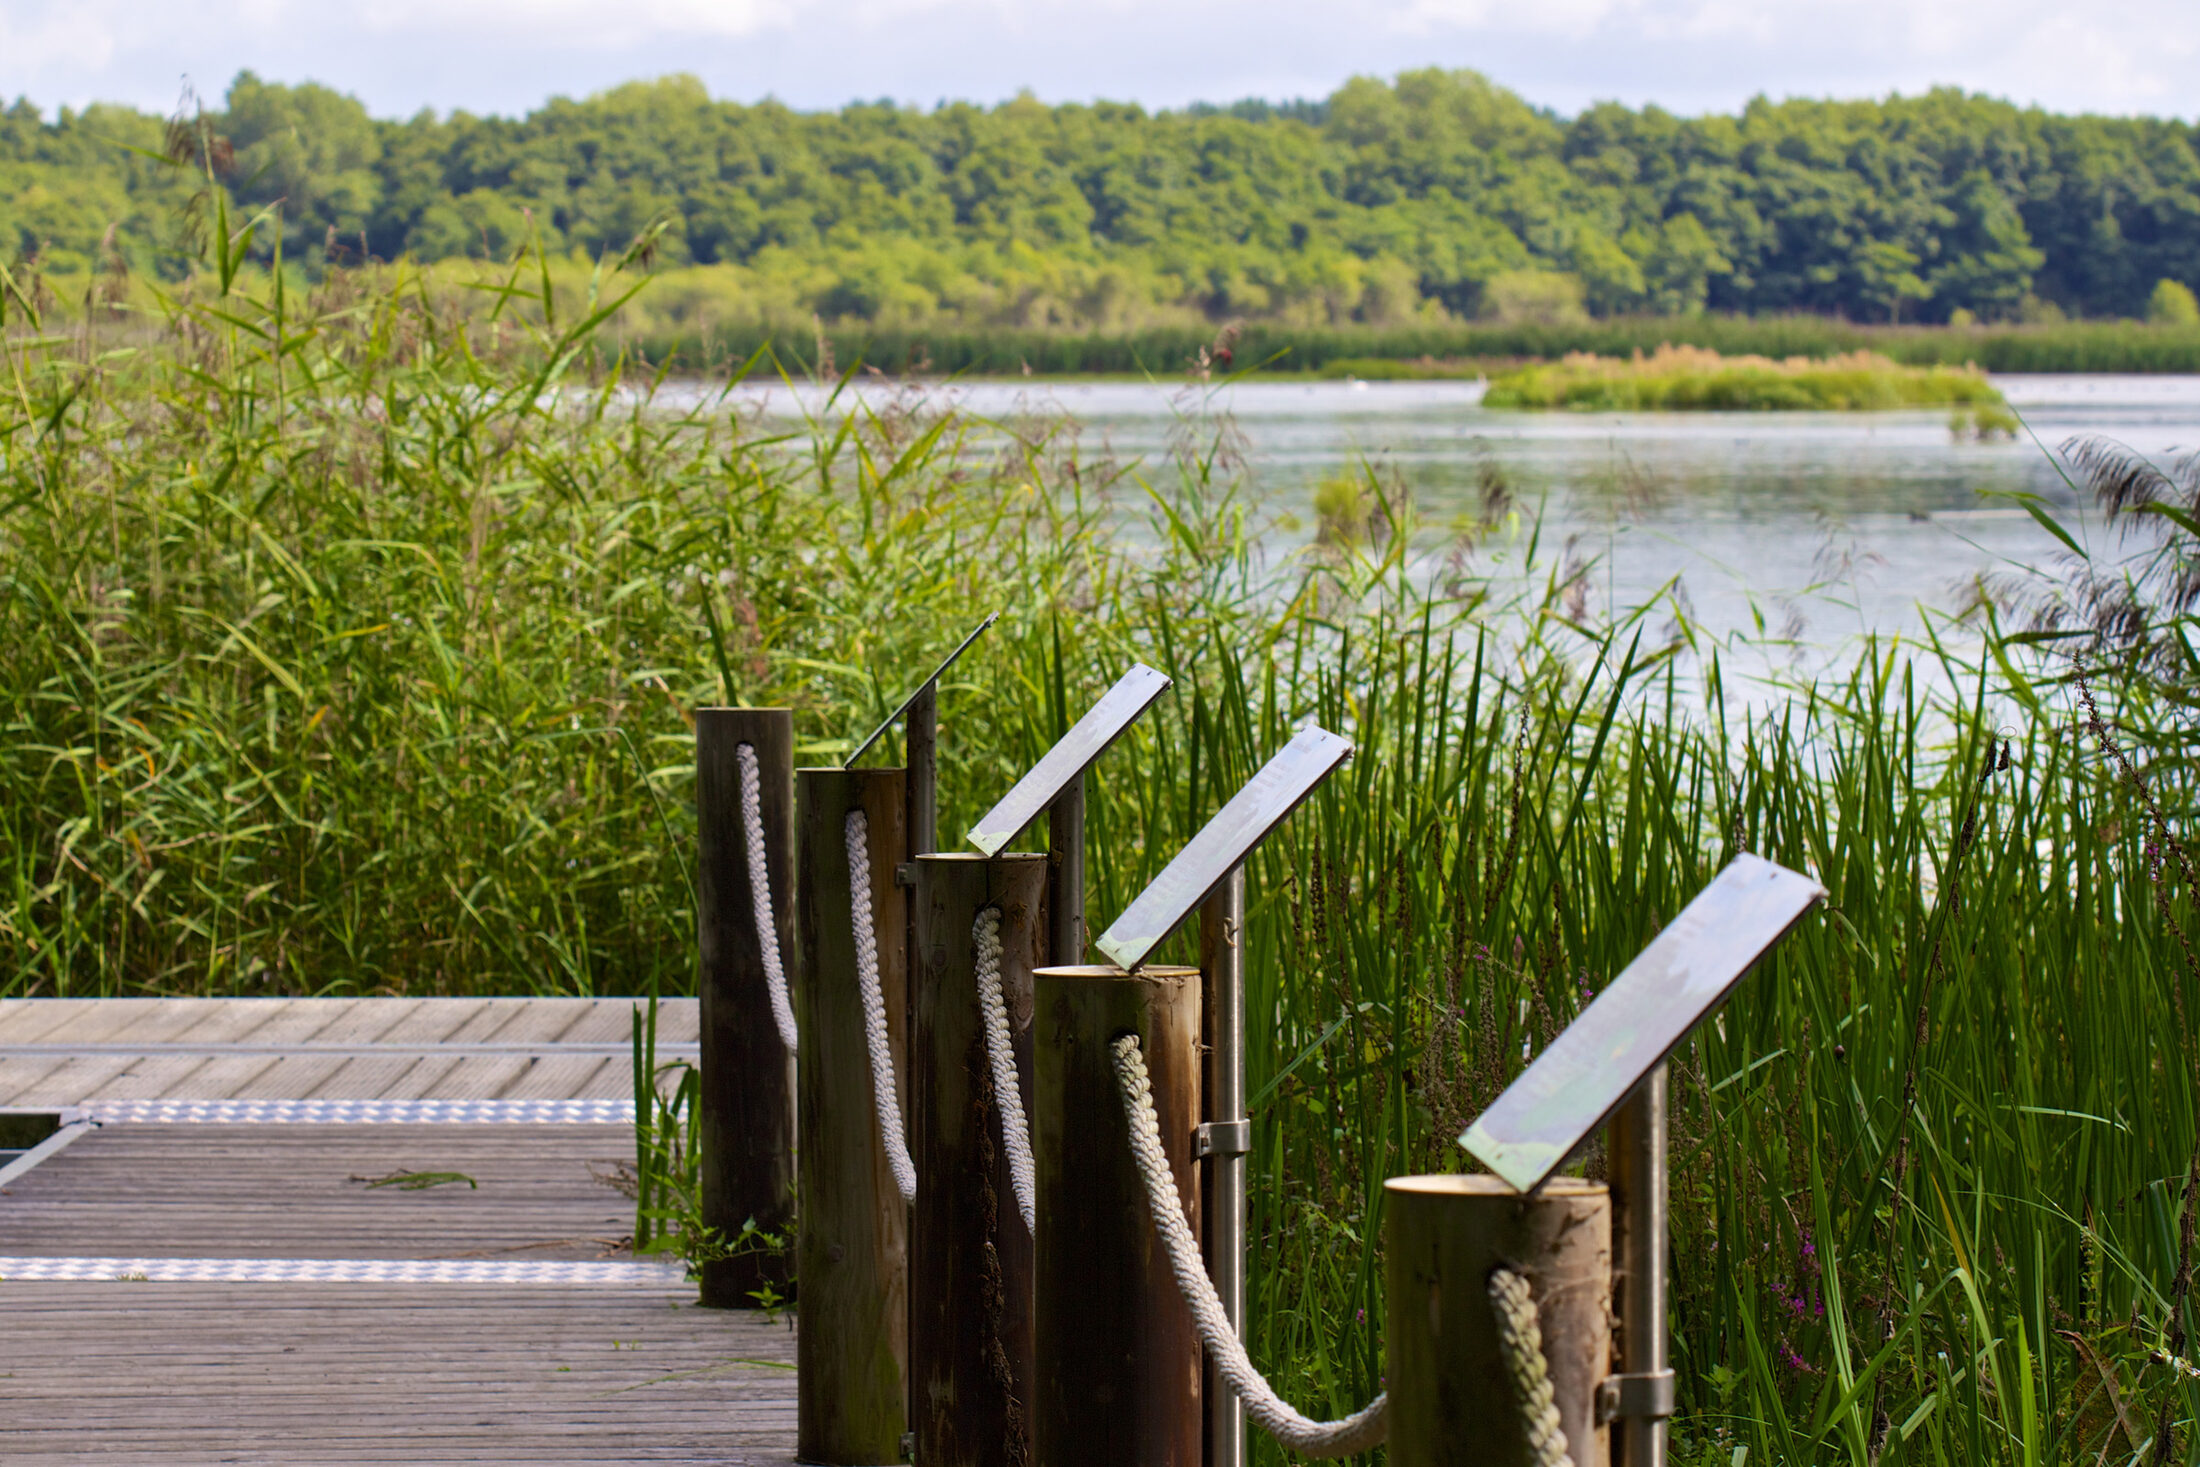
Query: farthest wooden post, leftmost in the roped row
695 708 794 1309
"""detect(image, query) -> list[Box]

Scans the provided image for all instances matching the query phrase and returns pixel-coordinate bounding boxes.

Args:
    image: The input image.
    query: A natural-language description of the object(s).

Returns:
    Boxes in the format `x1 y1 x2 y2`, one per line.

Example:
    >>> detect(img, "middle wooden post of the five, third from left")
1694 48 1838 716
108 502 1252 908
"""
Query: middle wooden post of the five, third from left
909 853 1047 1467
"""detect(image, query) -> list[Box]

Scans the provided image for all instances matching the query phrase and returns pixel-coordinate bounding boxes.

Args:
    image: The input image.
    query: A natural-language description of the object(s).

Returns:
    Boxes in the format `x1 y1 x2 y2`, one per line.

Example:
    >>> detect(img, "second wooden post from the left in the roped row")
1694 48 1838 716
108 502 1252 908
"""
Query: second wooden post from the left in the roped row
794 770 909 1467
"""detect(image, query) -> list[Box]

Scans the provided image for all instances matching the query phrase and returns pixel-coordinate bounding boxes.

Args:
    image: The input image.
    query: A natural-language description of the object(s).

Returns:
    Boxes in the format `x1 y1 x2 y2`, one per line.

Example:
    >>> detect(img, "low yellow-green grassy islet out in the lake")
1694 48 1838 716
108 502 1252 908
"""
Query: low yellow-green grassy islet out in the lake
1483 348 2006 406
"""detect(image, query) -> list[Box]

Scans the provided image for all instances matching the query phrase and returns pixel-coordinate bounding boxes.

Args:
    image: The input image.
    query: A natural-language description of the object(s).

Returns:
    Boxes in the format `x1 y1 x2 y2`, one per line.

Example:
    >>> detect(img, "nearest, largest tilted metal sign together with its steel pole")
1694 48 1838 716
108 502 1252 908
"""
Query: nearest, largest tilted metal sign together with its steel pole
1459 856 1826 1467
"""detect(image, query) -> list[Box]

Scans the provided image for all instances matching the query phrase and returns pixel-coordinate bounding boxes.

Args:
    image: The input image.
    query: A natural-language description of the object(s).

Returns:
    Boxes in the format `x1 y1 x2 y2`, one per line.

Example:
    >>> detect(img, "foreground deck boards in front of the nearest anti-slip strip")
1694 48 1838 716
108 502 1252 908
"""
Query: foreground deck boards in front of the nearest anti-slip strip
0 1282 794 1467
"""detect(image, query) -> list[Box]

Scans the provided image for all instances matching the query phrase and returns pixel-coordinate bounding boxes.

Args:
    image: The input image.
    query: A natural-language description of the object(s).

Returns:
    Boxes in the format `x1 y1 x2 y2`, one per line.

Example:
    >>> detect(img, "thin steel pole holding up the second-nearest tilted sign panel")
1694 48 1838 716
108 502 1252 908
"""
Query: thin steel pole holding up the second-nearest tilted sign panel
1199 867 1245 1467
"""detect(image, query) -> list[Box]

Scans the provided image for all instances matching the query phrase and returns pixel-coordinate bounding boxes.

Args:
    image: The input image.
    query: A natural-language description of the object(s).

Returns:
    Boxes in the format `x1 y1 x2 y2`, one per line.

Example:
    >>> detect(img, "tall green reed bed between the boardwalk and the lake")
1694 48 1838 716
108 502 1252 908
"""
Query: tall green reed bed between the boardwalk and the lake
0 258 2200 1467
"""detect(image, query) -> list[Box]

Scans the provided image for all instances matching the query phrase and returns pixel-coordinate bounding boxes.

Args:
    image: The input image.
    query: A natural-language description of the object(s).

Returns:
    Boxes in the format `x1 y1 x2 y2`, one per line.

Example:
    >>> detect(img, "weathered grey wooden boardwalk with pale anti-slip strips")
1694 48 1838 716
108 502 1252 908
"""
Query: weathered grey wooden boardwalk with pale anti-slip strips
0 999 794 1467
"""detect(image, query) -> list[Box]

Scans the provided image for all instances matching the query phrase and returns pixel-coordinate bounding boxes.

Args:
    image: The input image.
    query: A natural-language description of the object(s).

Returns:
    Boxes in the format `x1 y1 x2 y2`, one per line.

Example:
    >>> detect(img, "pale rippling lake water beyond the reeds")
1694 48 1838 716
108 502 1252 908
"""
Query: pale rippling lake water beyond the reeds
708 376 2200 699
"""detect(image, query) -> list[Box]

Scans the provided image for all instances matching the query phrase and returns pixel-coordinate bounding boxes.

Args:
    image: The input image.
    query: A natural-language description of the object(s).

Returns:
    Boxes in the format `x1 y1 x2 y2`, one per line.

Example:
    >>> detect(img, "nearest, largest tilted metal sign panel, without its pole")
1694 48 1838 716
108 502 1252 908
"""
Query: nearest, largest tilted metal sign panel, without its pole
1459 856 1826 1192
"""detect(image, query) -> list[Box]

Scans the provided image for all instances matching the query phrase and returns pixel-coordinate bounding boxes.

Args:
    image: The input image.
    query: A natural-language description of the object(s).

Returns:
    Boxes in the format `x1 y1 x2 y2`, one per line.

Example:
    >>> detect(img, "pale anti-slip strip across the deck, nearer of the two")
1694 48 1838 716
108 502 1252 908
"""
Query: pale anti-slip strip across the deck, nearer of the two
0 1258 686 1289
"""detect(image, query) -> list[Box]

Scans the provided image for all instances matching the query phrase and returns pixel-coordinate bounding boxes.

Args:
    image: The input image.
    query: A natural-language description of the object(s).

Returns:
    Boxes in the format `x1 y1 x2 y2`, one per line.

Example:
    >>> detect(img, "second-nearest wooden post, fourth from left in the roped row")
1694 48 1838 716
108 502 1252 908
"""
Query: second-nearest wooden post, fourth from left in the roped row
1032 966 1201 1467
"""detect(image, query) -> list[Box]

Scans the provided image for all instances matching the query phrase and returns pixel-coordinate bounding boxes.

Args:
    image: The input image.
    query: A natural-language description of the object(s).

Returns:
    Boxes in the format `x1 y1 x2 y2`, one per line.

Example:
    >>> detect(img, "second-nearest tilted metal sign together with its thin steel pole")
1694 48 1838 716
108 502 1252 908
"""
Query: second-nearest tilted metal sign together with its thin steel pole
1098 726 1353 1467
